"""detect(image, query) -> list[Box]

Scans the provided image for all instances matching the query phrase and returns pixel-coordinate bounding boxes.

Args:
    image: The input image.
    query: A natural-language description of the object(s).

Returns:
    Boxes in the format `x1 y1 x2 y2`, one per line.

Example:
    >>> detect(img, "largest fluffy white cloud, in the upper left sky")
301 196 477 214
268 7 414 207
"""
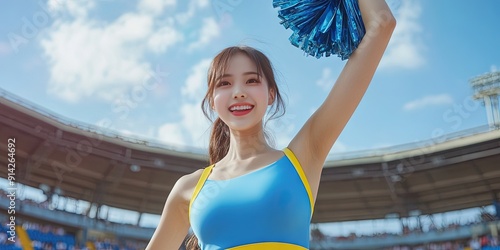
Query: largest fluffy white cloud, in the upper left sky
41 0 183 102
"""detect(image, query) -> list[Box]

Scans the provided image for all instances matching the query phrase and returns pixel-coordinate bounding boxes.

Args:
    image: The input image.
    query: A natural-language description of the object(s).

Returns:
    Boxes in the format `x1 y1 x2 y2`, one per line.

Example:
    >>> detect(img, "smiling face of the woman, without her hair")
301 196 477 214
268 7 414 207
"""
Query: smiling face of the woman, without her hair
212 53 273 131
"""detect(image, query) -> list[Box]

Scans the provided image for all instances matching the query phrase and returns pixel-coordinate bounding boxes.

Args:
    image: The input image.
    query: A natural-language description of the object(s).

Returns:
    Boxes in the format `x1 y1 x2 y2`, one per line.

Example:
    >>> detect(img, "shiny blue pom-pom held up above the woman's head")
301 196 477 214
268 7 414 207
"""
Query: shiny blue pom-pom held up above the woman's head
273 0 366 60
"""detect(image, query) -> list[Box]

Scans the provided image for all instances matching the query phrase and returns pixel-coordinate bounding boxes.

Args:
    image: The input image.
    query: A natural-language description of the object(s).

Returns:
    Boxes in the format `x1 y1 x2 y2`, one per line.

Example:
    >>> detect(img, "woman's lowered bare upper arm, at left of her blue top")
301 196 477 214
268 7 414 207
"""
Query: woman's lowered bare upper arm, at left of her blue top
146 176 195 250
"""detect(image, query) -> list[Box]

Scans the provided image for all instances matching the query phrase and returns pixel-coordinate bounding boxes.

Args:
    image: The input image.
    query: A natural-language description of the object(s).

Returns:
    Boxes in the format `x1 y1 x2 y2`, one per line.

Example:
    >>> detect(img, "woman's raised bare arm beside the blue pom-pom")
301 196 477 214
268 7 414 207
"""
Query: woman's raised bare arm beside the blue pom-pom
289 0 396 178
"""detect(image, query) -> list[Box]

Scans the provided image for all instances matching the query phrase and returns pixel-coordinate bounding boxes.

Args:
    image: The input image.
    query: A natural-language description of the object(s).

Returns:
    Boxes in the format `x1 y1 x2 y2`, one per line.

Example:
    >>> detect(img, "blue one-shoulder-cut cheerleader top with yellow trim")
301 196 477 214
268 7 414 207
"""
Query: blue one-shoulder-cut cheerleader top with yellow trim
189 148 314 250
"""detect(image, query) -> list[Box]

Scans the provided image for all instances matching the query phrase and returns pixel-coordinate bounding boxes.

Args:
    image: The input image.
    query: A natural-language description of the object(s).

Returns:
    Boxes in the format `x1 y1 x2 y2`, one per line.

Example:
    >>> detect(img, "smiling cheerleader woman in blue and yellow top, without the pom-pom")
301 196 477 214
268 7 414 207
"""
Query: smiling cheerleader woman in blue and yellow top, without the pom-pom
146 0 396 250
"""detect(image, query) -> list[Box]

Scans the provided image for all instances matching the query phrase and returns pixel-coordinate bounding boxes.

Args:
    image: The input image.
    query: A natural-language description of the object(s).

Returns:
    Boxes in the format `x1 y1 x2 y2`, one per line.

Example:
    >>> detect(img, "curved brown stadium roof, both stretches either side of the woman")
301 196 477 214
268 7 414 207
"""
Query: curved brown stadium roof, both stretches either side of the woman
0 92 500 222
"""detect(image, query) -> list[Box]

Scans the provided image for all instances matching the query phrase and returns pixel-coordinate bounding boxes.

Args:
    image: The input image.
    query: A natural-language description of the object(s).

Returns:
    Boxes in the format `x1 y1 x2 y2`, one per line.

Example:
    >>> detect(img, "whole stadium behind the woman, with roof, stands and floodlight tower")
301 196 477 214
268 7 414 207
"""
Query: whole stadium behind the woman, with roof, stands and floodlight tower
0 69 500 250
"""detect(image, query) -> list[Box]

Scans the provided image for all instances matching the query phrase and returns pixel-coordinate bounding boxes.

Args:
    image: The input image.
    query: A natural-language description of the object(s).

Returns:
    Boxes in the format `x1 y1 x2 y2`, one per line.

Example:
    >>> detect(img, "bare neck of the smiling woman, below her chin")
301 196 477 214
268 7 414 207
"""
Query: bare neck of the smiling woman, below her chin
225 126 272 160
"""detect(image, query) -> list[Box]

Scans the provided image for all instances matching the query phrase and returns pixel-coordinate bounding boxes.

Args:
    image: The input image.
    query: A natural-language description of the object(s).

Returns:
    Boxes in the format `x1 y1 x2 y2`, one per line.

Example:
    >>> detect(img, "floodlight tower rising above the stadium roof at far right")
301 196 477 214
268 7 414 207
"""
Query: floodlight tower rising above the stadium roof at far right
469 70 500 129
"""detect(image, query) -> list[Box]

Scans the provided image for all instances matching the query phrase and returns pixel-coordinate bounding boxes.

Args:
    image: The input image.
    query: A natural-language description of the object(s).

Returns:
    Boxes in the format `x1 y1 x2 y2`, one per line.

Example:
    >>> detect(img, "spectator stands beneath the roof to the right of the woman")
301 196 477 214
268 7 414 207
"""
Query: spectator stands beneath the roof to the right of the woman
311 212 500 250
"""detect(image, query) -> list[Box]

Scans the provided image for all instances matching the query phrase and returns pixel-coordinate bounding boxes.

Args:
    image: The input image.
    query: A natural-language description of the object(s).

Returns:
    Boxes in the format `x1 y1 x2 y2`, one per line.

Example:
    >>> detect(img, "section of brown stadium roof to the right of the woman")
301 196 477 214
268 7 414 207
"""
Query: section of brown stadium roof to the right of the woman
313 130 500 222
